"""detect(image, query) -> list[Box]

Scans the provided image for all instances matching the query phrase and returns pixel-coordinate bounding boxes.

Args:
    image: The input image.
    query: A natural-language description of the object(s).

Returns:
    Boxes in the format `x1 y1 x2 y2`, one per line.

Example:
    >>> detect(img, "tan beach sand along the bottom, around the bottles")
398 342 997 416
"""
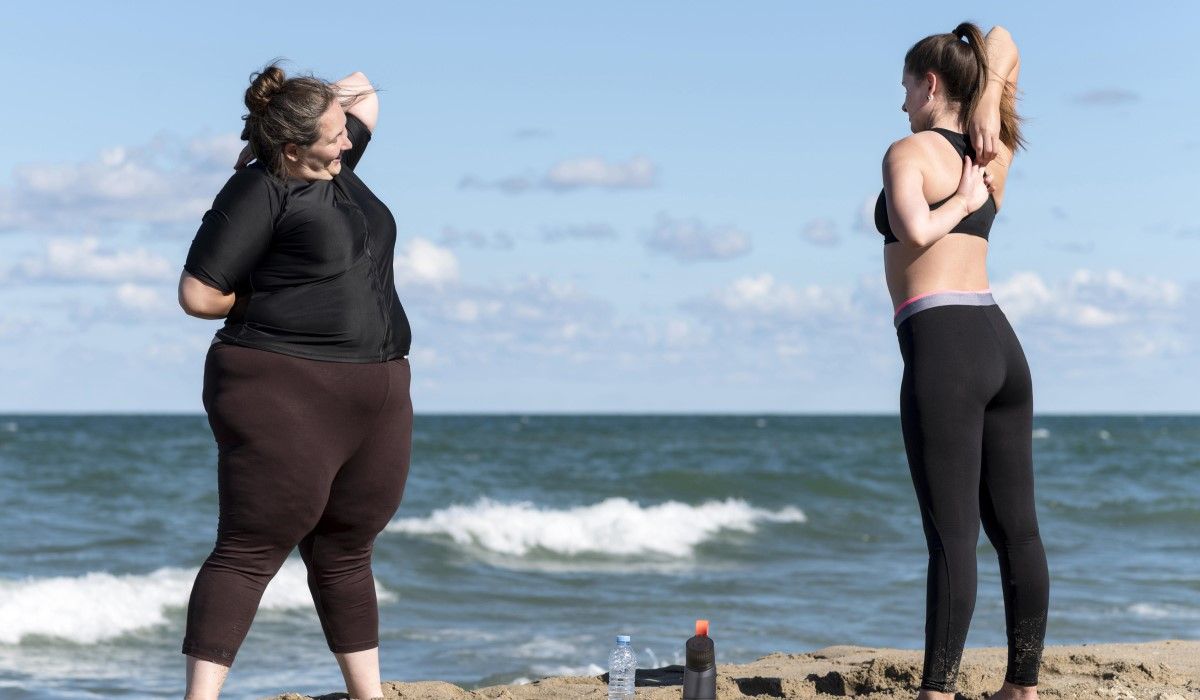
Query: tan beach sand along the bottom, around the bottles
274 640 1200 700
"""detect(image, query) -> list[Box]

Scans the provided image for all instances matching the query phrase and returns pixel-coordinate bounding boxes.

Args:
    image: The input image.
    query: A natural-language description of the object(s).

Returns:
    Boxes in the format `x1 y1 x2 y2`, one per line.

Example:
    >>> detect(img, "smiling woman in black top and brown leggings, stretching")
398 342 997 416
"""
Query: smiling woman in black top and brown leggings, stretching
179 65 413 700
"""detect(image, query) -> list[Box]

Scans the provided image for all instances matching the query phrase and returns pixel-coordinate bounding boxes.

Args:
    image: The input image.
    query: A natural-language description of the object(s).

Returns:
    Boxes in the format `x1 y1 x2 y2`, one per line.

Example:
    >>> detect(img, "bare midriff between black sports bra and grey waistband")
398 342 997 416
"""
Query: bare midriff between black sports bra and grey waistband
883 233 988 309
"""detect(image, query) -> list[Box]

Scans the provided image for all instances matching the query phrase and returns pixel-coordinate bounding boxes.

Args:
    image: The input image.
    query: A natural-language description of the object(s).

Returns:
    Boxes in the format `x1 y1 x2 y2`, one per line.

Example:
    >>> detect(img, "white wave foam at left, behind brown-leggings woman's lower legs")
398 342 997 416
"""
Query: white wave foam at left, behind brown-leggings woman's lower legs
0 560 394 644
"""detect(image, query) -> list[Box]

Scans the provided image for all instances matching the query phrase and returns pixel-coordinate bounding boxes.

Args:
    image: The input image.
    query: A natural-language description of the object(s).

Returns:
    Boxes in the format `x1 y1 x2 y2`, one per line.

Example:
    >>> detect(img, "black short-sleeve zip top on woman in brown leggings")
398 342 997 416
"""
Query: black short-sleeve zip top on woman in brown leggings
184 114 412 363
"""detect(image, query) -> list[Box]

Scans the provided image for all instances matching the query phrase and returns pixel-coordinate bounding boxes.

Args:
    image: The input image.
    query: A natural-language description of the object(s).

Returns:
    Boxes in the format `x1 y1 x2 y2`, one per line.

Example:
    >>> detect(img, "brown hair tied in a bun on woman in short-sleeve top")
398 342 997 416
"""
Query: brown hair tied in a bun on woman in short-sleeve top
241 60 337 179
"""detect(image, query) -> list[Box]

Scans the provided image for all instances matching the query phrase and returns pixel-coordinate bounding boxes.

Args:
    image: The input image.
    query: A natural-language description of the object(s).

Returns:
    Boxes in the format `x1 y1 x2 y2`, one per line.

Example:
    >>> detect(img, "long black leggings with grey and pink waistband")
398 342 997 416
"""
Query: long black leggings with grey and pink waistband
896 294 1050 693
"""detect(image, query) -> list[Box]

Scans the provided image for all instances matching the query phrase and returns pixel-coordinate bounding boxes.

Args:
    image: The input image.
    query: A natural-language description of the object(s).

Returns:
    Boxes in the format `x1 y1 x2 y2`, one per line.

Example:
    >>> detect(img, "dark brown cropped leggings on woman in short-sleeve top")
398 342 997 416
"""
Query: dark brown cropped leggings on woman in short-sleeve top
184 343 413 666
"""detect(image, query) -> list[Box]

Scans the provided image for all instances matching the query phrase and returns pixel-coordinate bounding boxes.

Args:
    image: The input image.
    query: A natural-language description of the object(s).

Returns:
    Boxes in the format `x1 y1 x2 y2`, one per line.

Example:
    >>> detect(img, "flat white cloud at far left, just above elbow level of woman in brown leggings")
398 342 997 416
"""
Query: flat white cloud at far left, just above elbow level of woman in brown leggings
12 237 173 282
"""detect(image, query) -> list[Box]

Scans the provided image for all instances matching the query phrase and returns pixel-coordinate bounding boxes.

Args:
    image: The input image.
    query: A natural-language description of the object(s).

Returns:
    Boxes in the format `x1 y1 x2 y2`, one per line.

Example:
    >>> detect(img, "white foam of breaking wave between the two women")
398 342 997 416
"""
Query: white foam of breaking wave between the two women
388 498 806 557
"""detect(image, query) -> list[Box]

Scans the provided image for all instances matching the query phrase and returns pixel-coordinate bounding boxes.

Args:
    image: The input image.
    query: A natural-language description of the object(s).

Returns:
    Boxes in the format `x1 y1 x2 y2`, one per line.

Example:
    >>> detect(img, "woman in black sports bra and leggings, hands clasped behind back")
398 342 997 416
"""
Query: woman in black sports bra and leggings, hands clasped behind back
875 23 1049 700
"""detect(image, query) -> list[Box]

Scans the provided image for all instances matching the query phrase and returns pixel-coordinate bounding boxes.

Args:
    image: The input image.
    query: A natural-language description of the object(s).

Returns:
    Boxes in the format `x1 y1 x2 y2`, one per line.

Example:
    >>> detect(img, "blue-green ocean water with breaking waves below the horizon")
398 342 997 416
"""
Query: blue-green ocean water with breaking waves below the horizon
0 415 1200 699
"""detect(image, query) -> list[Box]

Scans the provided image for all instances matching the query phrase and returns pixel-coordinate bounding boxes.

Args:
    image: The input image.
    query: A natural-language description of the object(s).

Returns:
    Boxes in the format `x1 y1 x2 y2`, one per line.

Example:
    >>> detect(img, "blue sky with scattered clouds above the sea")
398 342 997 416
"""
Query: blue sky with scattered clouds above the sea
0 2 1200 412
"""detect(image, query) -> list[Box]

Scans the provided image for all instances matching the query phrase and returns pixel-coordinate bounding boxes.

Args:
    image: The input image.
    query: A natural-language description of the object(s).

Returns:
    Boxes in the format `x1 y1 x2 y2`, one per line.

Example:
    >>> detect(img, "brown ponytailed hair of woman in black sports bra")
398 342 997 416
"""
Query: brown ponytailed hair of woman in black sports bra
904 22 1025 151
